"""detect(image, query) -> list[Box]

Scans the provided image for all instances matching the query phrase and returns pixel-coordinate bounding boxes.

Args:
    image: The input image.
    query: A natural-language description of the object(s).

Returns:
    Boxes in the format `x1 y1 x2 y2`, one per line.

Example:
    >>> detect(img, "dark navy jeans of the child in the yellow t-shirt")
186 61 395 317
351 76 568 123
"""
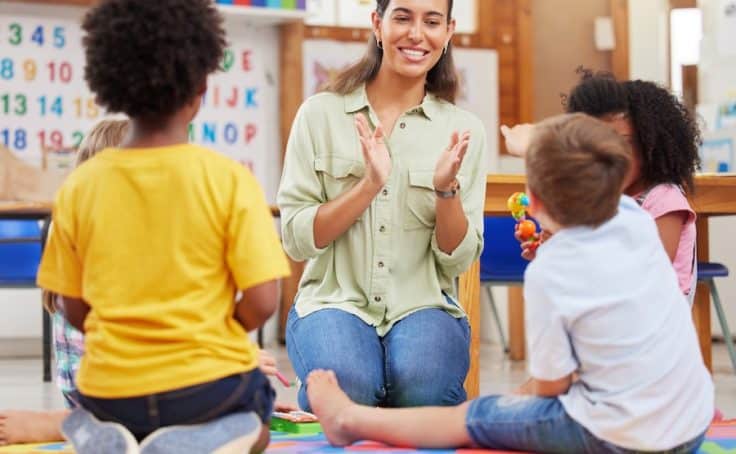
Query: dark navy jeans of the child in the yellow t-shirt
77 369 276 441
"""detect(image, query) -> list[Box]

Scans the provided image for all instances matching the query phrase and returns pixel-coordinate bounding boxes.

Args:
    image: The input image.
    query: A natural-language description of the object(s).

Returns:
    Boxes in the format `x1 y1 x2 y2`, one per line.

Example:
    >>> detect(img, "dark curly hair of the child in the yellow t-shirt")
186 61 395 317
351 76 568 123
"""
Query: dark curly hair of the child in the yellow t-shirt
82 0 226 119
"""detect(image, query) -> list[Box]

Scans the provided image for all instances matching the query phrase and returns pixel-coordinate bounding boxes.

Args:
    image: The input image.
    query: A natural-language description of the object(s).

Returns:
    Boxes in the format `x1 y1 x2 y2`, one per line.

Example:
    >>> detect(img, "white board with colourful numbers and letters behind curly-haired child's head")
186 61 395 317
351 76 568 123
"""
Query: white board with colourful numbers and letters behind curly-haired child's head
0 3 281 202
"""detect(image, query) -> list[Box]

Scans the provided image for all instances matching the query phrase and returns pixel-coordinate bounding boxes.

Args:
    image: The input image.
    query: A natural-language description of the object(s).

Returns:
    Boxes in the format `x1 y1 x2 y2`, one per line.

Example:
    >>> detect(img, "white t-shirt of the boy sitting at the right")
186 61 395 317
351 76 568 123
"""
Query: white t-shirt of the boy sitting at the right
524 196 714 450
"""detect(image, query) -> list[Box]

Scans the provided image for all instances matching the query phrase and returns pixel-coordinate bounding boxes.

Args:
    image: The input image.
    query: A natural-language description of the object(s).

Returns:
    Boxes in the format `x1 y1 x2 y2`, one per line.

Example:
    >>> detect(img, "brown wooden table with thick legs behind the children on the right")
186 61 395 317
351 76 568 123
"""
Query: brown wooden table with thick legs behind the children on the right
460 175 736 372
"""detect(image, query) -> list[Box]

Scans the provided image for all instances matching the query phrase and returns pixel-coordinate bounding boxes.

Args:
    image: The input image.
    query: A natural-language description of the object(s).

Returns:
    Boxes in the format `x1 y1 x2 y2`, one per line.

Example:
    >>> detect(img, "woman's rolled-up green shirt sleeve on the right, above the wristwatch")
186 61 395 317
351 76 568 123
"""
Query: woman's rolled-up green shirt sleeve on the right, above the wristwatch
431 121 487 278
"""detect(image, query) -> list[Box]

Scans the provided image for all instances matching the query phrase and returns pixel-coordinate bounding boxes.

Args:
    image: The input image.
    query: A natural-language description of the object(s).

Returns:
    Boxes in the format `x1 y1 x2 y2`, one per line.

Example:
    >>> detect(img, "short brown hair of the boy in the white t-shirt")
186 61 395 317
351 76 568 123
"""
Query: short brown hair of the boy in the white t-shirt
526 113 632 227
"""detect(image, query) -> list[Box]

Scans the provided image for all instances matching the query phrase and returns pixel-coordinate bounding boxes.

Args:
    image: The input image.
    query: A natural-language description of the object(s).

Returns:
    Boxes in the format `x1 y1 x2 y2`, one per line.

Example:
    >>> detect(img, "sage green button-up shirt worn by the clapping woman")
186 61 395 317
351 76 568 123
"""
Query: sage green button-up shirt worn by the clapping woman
277 87 486 336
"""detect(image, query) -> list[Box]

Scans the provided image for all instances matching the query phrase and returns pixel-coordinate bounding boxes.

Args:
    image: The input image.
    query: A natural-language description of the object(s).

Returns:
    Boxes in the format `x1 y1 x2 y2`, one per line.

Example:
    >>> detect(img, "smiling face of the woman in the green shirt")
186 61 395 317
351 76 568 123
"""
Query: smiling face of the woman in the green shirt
373 0 455 78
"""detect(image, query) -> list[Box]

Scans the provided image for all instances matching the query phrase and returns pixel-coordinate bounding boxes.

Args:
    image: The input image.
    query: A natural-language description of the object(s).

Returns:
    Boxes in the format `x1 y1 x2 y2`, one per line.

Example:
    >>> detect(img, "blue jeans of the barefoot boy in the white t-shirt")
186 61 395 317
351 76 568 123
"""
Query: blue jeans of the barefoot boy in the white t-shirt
465 395 705 454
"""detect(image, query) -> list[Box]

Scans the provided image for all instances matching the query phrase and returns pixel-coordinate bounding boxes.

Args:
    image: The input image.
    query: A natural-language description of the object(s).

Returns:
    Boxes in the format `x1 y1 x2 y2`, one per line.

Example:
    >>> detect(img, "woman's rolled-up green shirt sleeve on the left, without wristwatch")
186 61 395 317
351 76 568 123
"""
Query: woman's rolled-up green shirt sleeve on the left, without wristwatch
276 101 326 261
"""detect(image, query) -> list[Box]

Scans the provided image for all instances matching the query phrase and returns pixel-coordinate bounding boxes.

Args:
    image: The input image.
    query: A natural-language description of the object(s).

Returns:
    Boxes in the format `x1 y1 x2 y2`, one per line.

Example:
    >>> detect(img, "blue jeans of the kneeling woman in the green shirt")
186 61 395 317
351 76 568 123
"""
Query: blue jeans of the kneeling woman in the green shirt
286 308 470 410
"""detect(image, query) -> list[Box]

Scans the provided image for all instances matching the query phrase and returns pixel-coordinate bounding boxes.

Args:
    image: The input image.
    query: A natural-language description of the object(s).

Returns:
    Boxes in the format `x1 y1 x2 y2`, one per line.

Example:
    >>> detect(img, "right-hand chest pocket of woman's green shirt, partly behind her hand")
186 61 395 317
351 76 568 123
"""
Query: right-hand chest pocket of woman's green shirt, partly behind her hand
404 171 468 230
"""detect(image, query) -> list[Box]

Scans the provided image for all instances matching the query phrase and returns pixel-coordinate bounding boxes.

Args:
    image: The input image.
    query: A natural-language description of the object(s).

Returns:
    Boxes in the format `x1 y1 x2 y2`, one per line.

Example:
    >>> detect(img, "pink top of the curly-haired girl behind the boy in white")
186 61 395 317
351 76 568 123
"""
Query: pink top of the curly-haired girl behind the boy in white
637 184 695 295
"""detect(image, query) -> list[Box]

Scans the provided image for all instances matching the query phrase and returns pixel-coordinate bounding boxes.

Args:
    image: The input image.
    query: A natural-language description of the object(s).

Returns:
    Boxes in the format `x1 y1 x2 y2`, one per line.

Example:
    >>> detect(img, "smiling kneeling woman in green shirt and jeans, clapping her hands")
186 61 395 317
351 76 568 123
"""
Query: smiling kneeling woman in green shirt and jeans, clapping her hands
277 0 486 409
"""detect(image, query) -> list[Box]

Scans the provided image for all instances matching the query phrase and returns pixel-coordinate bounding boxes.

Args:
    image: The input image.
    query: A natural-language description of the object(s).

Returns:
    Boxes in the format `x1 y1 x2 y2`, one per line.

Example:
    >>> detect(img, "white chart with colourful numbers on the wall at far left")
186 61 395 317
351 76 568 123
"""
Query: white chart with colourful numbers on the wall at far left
0 15 95 165
